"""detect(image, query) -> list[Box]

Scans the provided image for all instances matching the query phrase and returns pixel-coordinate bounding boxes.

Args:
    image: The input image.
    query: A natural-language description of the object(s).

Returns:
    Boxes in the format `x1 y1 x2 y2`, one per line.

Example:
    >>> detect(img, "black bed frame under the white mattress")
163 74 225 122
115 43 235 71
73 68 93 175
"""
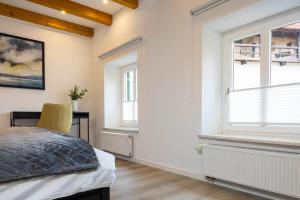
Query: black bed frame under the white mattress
55 187 110 200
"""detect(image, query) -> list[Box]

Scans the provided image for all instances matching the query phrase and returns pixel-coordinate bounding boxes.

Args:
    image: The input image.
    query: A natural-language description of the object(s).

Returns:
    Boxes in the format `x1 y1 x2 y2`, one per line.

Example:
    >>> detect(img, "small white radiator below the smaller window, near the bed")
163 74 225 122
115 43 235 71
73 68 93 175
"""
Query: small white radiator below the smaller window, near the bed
100 132 133 157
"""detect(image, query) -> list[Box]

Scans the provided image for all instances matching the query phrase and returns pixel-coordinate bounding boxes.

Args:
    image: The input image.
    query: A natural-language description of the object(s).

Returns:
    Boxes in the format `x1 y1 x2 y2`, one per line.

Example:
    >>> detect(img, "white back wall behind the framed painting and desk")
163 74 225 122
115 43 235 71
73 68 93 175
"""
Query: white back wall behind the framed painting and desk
0 17 92 131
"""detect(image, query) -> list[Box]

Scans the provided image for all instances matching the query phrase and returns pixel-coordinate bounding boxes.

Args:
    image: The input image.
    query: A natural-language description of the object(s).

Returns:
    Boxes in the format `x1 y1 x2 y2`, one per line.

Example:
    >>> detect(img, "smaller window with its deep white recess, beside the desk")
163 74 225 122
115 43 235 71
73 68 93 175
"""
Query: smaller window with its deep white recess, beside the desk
104 51 138 131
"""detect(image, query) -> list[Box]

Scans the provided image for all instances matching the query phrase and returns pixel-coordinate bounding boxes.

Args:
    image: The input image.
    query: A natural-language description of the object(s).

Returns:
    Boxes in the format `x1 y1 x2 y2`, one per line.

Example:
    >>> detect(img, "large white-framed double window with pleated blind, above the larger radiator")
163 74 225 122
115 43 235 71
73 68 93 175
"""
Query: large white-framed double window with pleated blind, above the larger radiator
225 23 300 133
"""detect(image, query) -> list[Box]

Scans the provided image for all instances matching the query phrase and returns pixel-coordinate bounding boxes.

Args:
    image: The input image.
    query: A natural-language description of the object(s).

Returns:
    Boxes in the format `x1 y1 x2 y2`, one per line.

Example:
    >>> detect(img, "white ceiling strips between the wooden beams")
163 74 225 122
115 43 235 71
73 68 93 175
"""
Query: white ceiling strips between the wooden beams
0 0 124 28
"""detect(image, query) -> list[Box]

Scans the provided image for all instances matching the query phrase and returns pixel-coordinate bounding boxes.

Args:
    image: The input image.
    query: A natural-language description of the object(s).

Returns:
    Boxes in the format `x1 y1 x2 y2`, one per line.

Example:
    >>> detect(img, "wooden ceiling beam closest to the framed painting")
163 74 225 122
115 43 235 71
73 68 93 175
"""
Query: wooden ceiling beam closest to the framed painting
0 3 94 37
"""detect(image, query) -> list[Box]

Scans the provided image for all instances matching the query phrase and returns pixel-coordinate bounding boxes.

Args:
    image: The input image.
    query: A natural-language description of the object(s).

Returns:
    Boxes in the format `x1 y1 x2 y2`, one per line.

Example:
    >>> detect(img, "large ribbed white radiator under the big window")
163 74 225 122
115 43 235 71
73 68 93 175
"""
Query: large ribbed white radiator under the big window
203 145 300 198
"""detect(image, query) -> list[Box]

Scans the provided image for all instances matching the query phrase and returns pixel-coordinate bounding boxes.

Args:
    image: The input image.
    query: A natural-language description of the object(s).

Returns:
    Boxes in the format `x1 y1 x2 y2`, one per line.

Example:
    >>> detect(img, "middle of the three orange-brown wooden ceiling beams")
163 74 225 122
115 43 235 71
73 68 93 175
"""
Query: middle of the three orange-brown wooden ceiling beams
26 0 113 26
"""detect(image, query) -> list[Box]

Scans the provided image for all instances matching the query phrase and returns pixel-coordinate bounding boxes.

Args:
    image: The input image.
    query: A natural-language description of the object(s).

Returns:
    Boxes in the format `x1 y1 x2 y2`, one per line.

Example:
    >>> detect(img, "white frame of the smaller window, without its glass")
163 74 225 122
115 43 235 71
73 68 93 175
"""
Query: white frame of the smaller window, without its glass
120 62 138 128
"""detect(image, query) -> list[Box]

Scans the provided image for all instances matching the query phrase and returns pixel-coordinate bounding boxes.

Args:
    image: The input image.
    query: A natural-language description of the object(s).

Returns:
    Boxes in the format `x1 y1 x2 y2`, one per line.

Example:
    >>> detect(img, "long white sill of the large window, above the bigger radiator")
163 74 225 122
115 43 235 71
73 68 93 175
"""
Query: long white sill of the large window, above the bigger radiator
198 133 300 147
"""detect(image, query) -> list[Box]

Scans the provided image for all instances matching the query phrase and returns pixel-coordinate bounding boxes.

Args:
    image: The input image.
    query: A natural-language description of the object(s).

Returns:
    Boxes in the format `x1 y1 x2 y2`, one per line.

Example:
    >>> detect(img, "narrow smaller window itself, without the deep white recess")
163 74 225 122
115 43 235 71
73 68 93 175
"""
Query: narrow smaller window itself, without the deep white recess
121 64 138 127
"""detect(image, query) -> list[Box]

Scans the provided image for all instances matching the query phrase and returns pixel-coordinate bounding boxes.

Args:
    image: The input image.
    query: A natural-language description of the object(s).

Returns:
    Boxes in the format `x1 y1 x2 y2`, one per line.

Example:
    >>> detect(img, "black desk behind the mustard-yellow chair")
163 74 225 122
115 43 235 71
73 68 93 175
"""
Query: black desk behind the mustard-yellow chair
10 111 90 141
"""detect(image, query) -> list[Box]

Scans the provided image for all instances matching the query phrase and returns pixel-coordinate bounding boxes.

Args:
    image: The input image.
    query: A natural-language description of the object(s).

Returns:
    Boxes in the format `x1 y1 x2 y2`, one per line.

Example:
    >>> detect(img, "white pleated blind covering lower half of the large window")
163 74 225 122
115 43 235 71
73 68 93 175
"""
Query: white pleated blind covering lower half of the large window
229 83 300 124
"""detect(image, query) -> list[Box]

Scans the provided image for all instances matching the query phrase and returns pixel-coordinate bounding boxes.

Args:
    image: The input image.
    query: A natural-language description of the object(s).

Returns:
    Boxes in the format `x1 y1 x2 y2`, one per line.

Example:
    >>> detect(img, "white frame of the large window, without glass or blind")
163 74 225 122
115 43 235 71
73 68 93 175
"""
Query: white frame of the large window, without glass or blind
221 12 300 134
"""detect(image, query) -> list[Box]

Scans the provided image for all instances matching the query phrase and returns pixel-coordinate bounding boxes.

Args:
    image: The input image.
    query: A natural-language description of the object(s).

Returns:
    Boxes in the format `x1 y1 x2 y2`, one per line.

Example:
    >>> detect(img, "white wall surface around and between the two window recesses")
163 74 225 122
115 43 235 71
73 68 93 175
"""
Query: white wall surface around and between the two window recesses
92 0 270 178
